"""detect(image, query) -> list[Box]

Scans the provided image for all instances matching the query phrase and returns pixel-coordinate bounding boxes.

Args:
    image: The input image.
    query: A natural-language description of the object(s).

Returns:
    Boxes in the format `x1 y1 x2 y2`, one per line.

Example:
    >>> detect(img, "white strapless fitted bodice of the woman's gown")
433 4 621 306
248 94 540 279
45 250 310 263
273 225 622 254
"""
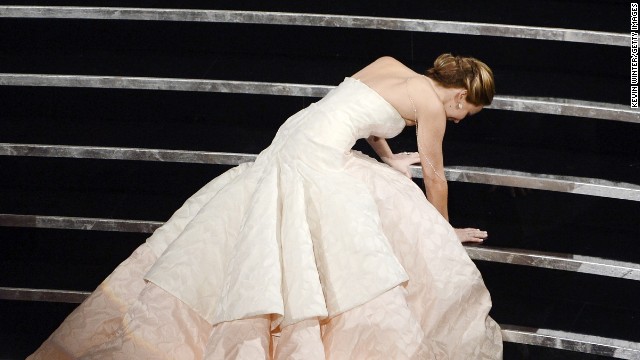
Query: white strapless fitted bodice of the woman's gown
275 77 405 151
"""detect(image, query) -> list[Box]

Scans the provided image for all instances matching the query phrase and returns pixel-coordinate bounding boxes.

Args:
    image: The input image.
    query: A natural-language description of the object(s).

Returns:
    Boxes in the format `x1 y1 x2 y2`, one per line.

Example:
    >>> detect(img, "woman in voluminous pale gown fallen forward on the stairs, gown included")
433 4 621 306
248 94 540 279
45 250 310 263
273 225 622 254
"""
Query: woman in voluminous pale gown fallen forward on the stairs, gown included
31 54 502 359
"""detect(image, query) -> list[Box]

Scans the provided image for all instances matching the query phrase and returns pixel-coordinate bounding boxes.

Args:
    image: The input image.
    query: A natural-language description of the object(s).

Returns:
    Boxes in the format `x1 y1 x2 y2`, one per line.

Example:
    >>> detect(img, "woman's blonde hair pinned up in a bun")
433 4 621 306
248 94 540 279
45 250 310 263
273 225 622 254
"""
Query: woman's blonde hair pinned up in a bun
425 54 496 106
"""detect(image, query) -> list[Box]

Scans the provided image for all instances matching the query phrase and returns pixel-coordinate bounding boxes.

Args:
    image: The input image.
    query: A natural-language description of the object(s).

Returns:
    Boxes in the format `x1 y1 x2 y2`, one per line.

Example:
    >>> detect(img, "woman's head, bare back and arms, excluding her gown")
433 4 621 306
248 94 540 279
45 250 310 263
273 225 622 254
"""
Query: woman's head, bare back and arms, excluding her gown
353 54 495 242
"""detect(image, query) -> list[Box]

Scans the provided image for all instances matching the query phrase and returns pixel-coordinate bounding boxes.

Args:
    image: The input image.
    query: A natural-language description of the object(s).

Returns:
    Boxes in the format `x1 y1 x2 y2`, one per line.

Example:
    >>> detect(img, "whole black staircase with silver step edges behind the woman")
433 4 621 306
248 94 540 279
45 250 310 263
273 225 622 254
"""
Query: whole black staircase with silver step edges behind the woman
0 0 640 359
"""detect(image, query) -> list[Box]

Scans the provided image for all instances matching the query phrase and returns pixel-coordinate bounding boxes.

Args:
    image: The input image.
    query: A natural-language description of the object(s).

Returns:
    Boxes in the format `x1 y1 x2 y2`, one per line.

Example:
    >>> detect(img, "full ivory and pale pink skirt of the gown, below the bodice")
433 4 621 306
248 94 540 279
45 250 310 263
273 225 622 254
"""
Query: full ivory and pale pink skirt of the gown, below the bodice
30 148 502 359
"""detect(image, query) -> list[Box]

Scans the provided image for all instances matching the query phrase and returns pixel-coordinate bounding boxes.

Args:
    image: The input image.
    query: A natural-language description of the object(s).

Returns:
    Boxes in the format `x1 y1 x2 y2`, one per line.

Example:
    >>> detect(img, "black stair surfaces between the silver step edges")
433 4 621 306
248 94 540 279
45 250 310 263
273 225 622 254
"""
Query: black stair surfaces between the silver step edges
0 0 640 359
